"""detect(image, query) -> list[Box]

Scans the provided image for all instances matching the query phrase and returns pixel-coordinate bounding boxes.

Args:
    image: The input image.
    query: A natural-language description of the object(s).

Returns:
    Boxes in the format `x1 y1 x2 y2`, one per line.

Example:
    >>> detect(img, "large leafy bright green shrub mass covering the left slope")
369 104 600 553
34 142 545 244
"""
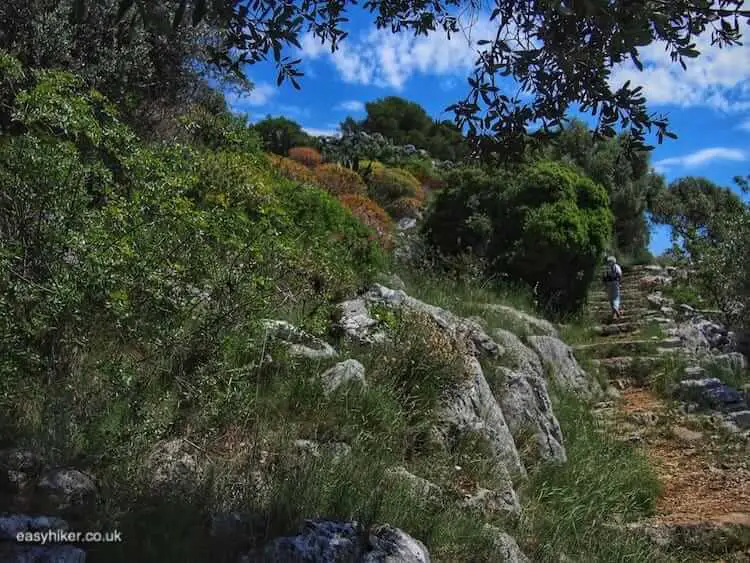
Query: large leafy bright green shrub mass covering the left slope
0 59 381 439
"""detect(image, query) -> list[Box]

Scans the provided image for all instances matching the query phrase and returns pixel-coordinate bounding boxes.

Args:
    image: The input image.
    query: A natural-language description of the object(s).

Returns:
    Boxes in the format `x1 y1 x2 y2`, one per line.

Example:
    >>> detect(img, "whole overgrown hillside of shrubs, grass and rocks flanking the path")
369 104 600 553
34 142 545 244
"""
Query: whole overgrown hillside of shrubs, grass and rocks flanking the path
0 1 750 563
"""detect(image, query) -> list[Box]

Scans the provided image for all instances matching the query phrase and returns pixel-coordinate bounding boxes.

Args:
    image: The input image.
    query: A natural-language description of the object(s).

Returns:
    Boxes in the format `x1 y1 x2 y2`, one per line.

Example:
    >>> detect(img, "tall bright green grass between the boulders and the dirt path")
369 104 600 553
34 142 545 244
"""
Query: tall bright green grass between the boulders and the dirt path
521 395 668 563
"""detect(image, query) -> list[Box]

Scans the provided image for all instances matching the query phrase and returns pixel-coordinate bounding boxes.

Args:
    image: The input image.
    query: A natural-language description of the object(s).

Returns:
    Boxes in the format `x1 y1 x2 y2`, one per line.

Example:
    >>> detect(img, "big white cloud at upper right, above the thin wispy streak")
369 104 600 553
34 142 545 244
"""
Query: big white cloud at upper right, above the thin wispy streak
610 20 750 113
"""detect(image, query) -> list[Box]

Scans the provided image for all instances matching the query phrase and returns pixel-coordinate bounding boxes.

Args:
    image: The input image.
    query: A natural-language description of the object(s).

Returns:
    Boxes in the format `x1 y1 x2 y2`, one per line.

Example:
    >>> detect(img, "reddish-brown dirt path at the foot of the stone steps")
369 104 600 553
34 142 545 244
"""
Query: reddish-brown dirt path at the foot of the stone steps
581 271 750 562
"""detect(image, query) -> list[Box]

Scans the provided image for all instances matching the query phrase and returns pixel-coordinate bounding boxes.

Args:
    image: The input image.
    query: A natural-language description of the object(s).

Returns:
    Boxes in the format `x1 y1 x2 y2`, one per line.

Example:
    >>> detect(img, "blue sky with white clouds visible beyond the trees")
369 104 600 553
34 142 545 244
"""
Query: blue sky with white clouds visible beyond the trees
228 8 750 254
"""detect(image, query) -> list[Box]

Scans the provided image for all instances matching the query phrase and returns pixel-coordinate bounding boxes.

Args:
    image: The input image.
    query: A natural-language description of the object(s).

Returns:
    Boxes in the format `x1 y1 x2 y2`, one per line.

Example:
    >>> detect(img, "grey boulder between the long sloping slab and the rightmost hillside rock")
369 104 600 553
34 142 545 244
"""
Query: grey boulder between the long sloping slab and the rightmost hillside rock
498 367 567 463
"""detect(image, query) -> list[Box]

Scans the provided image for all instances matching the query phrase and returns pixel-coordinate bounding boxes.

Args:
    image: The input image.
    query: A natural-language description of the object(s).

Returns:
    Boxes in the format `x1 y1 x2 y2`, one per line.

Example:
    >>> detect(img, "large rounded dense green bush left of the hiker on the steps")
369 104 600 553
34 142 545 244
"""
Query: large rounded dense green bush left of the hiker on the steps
425 161 612 313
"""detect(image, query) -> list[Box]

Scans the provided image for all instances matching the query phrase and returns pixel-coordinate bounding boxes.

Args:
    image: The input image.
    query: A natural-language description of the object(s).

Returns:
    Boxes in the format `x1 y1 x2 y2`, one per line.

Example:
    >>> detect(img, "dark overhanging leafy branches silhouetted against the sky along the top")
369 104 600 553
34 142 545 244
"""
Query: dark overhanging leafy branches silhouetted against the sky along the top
163 0 750 158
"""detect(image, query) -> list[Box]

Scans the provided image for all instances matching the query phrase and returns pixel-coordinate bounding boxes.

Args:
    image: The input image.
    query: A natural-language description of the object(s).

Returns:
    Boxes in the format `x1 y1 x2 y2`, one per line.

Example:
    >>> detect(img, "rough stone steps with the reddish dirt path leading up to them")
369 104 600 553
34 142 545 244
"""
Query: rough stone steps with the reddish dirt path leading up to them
573 266 750 562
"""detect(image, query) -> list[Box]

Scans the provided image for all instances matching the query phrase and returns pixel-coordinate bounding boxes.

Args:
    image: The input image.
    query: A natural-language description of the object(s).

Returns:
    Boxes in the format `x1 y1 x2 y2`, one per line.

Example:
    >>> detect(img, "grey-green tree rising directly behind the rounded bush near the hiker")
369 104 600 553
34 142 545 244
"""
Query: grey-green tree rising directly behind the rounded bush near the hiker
540 120 664 258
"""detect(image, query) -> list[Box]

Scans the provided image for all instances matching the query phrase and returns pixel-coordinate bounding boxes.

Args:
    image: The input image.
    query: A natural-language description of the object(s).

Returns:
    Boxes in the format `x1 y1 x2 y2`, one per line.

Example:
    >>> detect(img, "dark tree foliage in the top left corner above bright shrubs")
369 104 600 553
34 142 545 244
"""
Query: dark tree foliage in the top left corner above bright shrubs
0 0 250 136
